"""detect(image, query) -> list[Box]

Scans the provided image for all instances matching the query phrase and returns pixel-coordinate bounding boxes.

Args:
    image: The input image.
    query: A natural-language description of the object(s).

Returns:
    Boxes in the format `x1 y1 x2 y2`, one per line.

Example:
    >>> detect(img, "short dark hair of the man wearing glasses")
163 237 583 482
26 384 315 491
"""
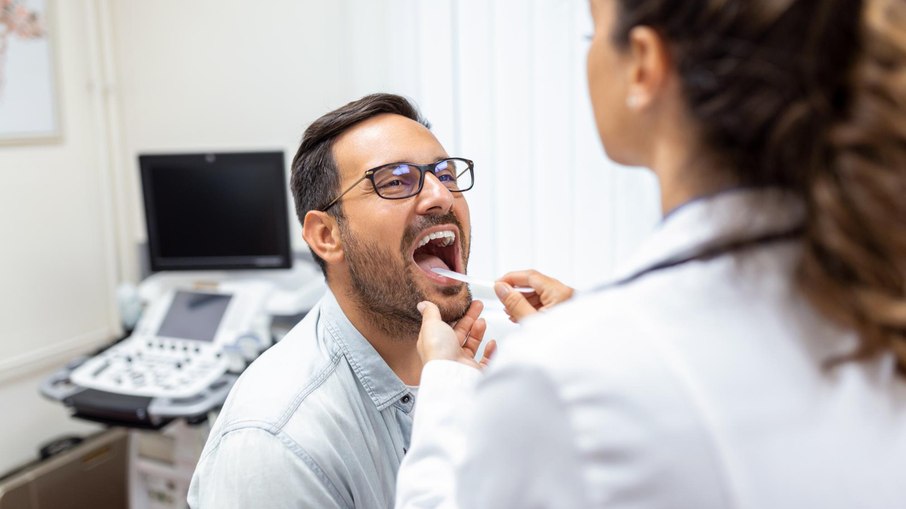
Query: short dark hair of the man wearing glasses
290 94 431 276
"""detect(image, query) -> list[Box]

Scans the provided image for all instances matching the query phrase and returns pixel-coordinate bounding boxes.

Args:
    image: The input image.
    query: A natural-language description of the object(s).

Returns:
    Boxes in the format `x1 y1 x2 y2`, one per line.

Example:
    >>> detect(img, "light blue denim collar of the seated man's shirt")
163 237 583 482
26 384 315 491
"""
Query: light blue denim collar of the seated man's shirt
321 288 411 410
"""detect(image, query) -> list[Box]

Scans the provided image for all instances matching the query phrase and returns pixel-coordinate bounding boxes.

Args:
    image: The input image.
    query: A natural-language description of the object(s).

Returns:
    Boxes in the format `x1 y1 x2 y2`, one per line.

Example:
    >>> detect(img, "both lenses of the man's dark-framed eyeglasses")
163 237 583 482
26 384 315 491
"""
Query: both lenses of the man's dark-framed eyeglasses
373 159 472 198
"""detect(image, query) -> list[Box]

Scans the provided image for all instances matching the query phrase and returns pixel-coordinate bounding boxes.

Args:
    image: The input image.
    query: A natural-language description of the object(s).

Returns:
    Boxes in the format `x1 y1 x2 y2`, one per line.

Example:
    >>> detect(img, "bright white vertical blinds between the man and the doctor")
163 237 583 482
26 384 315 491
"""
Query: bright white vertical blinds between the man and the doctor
342 0 660 288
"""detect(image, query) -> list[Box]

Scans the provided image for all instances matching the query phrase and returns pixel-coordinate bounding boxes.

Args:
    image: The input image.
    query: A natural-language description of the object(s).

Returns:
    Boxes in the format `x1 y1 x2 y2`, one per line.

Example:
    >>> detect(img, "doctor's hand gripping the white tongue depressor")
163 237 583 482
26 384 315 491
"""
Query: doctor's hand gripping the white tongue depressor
494 270 574 323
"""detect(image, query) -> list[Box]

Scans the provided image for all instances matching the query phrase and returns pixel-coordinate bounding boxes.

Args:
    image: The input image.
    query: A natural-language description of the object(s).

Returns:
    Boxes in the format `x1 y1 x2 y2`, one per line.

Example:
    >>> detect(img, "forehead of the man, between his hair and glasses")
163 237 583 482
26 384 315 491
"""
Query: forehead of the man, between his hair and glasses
333 114 447 177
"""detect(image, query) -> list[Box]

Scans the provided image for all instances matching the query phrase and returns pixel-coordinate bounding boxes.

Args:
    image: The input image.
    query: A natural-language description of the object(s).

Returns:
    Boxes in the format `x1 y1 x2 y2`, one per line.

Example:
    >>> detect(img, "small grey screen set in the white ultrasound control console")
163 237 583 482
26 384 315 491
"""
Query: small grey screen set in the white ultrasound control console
157 291 232 341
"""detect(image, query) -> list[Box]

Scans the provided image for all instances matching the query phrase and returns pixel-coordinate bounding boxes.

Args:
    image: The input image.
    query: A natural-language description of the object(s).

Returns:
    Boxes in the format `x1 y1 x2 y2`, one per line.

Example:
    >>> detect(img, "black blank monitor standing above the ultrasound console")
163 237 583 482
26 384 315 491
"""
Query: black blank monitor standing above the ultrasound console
138 152 292 271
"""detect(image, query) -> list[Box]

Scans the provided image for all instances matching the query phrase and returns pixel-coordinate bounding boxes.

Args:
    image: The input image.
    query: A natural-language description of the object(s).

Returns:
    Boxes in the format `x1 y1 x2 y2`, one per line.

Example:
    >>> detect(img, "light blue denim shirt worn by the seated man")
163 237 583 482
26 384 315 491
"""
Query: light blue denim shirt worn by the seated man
188 291 415 509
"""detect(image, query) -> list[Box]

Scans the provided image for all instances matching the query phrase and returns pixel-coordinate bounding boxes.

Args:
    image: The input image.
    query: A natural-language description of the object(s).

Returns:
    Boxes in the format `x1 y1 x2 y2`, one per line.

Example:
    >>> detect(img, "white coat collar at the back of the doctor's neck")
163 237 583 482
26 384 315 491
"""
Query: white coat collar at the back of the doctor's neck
615 188 805 280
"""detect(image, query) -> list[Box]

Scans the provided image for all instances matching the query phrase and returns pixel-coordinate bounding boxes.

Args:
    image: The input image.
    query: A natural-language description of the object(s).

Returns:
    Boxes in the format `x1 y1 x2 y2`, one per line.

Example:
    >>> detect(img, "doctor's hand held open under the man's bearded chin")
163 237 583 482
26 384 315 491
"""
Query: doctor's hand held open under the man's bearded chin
416 300 497 369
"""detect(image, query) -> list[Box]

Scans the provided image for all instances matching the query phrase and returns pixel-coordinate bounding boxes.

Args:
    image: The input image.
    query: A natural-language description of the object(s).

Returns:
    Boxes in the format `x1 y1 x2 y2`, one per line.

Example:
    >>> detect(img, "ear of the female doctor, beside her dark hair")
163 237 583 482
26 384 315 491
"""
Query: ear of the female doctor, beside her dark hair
627 26 670 109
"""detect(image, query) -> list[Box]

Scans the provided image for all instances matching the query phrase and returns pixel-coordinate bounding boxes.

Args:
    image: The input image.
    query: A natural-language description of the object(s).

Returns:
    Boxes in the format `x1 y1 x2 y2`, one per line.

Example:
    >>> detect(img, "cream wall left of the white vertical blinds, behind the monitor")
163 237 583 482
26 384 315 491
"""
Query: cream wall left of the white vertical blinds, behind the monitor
0 0 378 472
